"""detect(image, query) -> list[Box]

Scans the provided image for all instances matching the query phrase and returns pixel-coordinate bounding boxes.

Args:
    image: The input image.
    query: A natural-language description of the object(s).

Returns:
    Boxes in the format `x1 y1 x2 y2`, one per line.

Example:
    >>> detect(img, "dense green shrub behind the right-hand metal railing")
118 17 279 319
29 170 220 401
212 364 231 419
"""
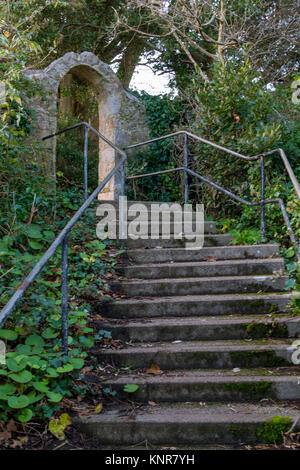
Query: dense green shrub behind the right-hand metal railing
190 61 300 236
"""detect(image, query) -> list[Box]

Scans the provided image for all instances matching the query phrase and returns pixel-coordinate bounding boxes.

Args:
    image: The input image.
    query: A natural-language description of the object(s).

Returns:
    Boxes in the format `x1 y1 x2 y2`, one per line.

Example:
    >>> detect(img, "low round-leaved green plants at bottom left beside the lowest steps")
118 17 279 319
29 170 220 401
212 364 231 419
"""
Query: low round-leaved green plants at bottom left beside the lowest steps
0 312 93 422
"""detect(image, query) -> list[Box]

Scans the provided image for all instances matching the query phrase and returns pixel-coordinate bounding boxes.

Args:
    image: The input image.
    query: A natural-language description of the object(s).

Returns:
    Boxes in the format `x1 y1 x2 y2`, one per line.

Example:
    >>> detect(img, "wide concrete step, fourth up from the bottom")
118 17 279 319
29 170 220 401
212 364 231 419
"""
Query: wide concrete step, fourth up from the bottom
96 315 300 343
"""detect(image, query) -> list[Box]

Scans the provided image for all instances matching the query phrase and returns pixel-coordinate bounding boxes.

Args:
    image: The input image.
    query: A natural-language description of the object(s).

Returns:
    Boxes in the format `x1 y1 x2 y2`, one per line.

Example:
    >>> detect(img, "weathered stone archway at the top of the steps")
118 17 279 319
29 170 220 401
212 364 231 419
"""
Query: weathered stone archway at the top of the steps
24 52 149 199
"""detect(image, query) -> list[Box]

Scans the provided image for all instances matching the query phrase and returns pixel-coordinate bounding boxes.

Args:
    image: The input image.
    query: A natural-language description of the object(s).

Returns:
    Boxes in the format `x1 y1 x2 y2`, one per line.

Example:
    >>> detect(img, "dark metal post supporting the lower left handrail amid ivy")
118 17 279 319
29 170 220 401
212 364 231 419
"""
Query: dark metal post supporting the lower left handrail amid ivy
61 235 69 356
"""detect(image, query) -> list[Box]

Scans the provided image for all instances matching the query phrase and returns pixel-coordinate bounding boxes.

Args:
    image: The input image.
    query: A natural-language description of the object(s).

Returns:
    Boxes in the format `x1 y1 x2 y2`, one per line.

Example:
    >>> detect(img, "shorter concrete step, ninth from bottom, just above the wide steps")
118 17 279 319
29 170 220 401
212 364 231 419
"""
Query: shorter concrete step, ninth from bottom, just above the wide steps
125 234 231 248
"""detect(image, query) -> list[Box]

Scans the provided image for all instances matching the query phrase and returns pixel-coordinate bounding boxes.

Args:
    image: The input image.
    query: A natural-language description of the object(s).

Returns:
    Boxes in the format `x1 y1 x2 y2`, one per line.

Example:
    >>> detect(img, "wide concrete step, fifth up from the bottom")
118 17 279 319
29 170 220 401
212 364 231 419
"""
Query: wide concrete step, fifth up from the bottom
97 294 291 319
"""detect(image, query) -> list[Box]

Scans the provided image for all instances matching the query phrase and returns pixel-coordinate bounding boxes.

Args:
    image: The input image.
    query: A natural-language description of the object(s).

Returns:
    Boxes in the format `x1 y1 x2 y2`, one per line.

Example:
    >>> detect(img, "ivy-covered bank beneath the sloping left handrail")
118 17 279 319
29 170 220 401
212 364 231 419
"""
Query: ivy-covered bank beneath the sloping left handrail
0 185 118 423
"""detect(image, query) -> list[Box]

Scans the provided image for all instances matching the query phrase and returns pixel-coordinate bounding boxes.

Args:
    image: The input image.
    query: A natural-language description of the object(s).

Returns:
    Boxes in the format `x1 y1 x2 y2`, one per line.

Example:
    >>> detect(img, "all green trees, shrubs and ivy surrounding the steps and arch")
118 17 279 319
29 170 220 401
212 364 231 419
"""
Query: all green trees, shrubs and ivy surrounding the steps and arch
0 0 300 442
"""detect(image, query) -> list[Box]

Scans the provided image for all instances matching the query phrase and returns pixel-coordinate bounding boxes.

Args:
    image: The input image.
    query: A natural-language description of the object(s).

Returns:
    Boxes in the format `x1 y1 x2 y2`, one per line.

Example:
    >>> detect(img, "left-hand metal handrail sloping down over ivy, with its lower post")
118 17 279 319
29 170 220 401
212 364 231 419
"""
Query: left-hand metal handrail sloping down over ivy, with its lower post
0 123 127 355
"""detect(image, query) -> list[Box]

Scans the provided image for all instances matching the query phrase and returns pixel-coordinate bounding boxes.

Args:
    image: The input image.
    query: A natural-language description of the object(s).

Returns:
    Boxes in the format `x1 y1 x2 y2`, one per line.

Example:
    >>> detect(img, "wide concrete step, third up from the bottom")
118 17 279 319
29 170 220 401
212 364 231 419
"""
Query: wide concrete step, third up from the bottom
99 339 294 371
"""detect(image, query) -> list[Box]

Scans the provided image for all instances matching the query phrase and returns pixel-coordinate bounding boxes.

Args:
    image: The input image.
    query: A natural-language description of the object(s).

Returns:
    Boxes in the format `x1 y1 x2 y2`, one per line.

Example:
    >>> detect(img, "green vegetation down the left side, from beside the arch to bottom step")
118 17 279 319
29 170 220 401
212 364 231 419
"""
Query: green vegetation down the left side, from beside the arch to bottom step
0 6 118 423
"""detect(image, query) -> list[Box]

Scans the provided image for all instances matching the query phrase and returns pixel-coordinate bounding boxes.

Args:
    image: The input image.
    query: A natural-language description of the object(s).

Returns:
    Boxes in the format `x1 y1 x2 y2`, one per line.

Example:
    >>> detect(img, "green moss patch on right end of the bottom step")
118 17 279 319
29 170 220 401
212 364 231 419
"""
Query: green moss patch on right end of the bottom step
256 416 292 444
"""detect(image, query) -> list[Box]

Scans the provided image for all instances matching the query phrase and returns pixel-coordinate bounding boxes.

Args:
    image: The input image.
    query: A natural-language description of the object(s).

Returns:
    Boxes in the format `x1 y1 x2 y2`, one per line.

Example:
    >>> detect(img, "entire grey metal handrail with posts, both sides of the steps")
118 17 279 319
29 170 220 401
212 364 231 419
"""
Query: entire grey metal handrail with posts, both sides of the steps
0 122 300 355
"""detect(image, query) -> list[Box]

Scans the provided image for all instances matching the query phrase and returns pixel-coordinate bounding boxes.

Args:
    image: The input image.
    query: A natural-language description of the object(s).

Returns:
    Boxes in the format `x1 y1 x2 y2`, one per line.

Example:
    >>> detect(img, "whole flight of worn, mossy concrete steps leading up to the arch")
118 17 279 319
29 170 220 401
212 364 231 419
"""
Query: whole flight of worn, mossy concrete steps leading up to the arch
80 202 300 449
